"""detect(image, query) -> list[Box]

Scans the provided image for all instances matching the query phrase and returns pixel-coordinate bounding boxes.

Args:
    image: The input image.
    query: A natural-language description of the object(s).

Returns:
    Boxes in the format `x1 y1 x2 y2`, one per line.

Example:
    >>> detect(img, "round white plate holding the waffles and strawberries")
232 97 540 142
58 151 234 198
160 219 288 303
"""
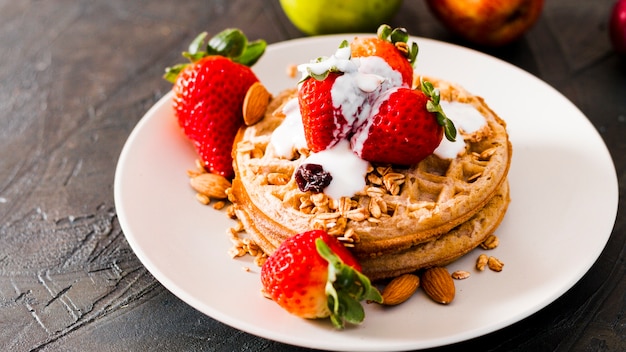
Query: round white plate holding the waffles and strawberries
115 35 618 351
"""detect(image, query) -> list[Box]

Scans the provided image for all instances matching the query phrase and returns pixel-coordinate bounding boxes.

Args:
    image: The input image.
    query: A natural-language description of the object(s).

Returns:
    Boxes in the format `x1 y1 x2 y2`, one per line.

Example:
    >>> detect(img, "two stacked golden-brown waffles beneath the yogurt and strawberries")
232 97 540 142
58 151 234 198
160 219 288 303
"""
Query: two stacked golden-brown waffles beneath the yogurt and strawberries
231 79 511 277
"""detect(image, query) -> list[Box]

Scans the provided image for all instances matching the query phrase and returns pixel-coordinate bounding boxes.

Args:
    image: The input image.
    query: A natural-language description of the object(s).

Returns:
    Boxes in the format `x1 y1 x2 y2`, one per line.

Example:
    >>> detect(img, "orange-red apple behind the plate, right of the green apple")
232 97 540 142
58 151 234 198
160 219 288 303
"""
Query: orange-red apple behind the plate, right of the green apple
426 0 544 46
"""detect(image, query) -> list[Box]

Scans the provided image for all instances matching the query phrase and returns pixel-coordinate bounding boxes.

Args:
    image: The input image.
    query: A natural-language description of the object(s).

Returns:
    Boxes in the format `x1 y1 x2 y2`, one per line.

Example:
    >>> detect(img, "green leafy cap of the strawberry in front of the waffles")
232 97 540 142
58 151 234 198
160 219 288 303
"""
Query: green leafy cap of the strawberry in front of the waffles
315 238 382 329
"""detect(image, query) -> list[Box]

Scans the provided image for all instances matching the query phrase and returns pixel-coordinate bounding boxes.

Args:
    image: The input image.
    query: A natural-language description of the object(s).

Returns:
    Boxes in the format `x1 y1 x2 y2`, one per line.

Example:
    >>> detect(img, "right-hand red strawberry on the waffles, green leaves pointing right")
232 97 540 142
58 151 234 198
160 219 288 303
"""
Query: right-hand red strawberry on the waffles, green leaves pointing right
350 82 456 165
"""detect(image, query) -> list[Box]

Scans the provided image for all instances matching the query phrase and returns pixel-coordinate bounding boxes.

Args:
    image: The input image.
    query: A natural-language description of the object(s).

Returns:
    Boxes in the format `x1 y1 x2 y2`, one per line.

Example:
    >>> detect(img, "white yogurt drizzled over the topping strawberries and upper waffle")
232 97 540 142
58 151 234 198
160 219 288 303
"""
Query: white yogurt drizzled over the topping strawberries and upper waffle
270 46 486 199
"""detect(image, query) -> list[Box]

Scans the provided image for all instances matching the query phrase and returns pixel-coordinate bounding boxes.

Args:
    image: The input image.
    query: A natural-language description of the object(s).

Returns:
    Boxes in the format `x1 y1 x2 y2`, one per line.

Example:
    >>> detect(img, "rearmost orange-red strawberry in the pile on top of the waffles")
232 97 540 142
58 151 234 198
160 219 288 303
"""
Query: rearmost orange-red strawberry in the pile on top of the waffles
350 25 418 87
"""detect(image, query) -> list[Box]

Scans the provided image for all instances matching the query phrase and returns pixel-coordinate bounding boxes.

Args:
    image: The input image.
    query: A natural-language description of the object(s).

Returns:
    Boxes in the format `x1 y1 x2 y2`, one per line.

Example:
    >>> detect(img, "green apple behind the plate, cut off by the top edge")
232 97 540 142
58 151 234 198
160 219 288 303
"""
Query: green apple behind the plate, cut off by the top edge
280 0 402 35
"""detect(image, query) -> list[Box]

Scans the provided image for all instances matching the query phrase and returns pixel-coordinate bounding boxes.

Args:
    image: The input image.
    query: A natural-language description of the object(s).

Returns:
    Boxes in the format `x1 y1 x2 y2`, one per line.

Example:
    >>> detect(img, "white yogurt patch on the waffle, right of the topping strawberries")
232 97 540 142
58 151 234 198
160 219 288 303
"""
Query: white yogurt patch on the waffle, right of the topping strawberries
433 100 487 159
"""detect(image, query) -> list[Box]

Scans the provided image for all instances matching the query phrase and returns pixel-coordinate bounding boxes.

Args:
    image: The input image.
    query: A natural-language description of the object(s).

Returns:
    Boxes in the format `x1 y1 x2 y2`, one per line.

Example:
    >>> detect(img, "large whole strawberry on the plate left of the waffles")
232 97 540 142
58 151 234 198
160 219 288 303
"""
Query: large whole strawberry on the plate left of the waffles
164 29 266 178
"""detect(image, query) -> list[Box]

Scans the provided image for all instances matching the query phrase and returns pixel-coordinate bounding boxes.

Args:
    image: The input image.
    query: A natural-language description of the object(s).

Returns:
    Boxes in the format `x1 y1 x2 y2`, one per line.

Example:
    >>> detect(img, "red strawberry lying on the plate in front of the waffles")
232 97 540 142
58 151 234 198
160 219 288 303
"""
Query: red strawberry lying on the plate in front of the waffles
261 230 382 328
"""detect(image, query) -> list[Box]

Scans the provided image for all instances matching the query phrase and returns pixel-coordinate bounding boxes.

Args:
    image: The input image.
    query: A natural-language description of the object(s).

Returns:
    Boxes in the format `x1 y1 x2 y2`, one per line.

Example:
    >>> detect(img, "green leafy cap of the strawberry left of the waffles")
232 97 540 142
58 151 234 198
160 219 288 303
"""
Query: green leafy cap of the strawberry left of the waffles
163 28 267 83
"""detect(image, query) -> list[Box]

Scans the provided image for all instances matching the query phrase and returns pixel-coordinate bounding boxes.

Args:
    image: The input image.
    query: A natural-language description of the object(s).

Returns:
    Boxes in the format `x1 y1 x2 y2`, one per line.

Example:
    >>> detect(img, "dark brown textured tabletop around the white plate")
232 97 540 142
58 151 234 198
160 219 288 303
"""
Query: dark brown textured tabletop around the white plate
0 0 626 351
